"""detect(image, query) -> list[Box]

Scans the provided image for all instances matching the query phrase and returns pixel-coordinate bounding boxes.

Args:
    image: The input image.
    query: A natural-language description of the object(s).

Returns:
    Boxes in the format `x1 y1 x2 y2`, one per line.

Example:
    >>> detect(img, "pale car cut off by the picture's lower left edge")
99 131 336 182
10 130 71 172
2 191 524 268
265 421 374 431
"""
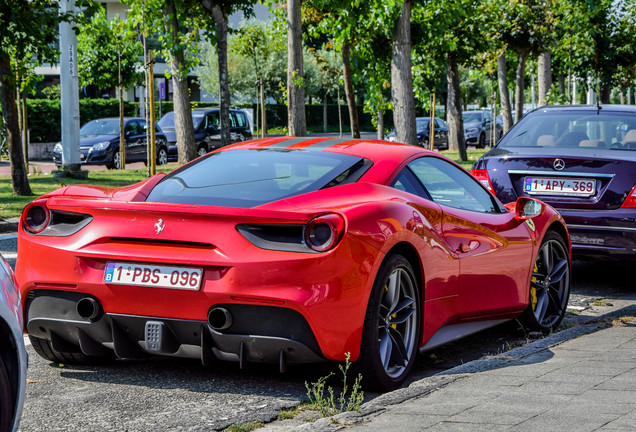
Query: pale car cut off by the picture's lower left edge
0 255 27 432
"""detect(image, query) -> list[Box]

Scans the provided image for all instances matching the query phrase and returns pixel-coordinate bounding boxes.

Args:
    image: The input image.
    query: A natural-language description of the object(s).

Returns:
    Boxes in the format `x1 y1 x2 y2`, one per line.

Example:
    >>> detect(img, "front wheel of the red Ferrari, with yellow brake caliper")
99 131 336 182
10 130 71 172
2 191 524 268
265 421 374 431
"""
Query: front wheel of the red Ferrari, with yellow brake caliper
520 231 572 334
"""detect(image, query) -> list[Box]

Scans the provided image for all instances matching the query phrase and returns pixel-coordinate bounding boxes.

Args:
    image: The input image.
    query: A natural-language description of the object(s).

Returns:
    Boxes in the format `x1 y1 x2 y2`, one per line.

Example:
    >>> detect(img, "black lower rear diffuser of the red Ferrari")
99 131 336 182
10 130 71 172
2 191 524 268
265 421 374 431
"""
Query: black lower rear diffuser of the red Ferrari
25 290 325 370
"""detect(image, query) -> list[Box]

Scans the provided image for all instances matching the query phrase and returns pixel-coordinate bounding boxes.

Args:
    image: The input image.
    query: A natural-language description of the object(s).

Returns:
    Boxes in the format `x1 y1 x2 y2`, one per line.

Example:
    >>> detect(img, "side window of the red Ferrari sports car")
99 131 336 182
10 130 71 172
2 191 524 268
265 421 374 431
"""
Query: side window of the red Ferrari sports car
408 157 501 213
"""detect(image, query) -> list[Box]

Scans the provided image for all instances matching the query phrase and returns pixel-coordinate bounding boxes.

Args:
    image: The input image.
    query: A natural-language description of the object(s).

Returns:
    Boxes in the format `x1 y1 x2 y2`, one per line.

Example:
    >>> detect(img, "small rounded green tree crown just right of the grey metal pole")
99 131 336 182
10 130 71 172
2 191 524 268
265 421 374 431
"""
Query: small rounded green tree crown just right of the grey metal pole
77 9 143 94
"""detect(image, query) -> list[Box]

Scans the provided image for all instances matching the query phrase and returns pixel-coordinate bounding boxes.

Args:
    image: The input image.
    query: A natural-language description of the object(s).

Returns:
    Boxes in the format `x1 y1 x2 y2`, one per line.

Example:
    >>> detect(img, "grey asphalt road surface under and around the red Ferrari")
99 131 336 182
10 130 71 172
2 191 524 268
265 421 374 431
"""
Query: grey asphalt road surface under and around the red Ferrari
0 234 636 431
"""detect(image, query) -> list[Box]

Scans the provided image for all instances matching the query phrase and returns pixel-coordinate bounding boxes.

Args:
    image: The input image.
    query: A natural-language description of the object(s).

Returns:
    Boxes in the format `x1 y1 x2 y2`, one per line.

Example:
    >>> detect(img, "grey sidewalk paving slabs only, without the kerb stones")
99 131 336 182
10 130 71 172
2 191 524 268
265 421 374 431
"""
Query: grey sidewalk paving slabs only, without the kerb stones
346 323 636 432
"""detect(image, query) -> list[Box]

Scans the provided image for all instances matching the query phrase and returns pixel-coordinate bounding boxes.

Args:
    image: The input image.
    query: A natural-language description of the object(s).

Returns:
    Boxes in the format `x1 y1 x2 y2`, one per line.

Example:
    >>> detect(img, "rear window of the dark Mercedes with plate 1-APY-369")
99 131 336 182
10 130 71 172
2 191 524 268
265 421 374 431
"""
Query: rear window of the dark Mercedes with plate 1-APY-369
497 109 636 151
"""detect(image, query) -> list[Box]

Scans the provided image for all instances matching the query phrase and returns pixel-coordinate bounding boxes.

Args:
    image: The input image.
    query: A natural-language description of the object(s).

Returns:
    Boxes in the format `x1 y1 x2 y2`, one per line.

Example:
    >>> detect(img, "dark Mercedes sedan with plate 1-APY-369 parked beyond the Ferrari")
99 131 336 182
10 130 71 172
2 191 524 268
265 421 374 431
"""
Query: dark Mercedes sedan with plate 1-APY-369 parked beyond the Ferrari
472 105 636 260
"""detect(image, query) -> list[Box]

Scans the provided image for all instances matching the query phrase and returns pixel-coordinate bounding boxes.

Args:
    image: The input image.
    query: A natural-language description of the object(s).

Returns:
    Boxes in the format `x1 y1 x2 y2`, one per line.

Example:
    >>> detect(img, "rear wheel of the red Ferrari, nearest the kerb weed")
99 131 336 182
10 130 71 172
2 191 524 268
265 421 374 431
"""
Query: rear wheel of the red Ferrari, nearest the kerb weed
357 255 421 392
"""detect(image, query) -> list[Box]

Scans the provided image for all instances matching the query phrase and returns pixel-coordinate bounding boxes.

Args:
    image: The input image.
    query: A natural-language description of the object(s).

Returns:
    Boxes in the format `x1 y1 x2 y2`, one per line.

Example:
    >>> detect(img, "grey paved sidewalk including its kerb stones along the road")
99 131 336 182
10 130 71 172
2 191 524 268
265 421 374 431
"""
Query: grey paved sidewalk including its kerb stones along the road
258 305 636 432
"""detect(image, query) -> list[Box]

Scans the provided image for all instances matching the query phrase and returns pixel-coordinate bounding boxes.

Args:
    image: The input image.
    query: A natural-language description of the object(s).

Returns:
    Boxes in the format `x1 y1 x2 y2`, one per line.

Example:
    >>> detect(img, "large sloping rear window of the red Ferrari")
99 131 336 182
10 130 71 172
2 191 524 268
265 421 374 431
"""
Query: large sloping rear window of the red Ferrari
146 149 371 208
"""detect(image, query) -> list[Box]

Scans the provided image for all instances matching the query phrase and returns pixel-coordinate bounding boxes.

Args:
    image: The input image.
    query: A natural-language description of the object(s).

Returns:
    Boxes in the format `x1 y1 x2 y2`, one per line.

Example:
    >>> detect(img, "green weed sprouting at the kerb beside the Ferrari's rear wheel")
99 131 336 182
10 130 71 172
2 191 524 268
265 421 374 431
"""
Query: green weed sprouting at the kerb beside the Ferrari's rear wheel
305 353 364 417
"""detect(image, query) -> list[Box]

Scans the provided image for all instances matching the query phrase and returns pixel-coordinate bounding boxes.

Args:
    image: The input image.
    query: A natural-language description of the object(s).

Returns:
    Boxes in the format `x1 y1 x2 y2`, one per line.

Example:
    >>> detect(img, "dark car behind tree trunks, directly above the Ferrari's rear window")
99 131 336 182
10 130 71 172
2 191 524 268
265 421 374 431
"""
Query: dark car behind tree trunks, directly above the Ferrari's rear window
159 108 252 160
